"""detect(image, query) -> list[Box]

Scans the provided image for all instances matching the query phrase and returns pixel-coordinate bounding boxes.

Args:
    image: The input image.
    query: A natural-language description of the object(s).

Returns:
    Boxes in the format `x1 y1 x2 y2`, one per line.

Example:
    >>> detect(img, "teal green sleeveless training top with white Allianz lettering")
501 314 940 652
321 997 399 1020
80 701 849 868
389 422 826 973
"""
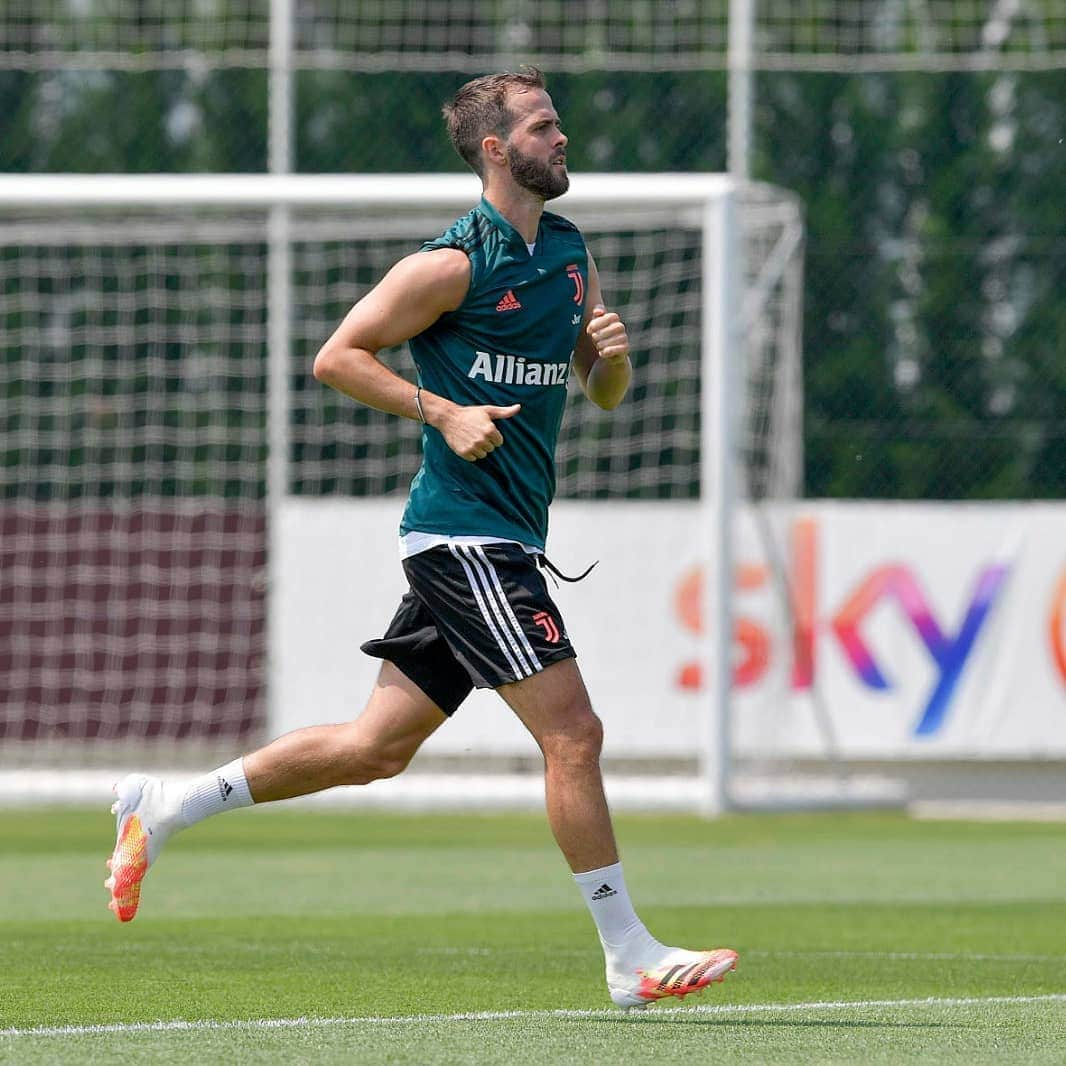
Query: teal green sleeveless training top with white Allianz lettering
400 199 588 549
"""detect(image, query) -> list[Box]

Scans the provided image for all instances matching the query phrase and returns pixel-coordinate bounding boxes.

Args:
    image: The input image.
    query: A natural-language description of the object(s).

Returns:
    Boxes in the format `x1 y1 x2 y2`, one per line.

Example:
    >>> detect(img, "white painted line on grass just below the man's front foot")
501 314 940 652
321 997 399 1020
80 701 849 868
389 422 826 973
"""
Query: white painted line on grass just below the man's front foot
0 992 1066 1037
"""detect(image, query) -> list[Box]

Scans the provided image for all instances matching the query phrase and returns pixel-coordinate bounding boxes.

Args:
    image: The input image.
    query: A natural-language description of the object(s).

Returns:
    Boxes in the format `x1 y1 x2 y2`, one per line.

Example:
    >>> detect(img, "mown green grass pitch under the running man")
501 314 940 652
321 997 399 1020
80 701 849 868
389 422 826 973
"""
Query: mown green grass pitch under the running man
0 807 1066 1066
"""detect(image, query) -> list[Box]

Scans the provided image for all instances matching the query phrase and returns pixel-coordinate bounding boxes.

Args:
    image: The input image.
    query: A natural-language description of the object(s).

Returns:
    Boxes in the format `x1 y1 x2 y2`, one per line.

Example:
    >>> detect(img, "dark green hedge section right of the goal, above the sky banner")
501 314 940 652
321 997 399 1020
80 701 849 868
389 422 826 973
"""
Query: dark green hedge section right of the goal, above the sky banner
756 72 1066 499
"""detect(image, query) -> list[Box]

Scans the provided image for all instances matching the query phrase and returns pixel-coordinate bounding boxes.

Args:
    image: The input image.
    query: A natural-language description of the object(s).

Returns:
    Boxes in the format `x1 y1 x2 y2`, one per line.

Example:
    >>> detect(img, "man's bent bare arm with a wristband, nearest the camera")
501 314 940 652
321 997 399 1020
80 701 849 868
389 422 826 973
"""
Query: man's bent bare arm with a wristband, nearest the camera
313 248 518 462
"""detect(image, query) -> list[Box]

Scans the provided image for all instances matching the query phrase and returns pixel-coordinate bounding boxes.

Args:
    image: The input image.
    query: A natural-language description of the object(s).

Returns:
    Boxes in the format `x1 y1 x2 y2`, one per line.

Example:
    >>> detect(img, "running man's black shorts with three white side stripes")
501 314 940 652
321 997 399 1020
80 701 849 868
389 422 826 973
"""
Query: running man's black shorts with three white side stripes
362 544 575 715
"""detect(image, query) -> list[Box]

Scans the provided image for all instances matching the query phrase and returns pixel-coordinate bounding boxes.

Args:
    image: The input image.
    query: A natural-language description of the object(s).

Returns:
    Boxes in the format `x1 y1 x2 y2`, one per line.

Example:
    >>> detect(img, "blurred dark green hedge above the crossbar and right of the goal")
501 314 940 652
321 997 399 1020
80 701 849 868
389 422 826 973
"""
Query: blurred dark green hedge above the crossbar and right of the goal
0 7 1066 499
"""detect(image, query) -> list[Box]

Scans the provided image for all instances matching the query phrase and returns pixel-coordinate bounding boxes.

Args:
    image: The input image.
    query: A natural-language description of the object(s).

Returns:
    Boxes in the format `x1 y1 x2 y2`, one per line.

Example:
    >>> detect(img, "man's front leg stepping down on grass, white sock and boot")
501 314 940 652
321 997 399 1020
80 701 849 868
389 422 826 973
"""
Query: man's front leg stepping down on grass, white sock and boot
498 659 737 1008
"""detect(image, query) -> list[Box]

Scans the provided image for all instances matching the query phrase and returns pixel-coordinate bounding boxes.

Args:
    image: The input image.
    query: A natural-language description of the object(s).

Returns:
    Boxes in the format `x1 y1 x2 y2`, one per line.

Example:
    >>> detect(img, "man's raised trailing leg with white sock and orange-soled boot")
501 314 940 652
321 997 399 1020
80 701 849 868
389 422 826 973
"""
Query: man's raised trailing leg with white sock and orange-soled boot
104 662 447 921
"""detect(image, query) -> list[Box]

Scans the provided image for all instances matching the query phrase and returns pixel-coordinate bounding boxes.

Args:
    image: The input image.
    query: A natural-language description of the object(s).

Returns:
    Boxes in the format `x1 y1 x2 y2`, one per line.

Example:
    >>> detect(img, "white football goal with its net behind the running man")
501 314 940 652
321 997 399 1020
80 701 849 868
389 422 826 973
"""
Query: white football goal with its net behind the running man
0 174 803 813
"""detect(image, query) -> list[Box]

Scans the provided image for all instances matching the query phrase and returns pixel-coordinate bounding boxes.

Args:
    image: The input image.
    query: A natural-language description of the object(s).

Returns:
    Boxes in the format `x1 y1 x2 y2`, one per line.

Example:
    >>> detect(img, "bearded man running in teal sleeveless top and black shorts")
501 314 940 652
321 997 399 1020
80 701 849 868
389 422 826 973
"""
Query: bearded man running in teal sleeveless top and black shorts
106 68 737 1008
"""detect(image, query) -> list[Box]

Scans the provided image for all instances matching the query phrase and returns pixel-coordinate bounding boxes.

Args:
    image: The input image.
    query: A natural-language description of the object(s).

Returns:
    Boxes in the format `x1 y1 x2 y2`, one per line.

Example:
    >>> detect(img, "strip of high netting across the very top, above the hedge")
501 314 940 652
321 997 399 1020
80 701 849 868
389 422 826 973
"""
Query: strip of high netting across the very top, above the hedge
0 0 1066 71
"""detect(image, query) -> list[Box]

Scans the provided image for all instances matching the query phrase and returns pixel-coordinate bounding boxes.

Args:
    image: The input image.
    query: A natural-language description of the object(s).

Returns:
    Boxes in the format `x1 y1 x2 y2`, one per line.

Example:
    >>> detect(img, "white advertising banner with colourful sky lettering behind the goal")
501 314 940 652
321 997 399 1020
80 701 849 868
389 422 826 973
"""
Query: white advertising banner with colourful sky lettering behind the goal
272 500 1066 759
